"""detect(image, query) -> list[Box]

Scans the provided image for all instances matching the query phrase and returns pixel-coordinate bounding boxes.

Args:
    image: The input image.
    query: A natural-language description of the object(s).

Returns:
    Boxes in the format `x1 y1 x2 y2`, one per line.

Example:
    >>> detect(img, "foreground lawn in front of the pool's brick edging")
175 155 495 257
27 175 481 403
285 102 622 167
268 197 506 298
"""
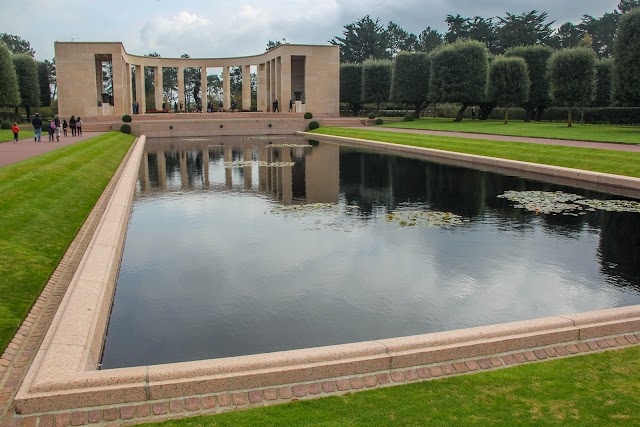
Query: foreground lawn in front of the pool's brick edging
147 347 640 427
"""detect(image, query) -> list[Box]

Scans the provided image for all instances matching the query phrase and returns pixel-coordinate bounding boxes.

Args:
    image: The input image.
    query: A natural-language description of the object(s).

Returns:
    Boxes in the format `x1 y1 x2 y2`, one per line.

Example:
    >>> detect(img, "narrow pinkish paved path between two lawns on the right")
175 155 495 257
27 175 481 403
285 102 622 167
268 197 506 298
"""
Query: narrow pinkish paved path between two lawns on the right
352 126 640 152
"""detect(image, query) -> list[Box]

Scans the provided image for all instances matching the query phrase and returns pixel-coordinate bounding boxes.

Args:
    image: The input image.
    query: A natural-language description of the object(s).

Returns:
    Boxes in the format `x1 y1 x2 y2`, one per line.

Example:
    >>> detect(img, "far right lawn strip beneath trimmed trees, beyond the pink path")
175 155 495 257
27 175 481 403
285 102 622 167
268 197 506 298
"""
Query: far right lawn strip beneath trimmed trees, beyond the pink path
382 118 640 144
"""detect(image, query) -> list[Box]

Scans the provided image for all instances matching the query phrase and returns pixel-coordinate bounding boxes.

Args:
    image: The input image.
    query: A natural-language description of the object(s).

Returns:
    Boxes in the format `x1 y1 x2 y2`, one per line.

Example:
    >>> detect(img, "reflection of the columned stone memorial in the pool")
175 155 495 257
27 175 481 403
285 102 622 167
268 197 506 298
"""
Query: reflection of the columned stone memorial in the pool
138 137 340 204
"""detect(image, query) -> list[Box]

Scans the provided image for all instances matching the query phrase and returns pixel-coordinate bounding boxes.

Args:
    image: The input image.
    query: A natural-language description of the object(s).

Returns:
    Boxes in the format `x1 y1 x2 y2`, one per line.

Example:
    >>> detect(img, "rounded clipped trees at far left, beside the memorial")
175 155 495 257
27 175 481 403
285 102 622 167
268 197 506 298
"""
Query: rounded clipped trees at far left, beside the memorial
0 33 56 120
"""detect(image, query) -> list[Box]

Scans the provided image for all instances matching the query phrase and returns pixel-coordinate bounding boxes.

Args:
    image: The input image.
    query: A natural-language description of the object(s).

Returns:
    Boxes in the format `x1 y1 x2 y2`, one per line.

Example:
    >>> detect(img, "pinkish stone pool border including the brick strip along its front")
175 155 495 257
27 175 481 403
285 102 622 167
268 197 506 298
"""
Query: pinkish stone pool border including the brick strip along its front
15 135 640 426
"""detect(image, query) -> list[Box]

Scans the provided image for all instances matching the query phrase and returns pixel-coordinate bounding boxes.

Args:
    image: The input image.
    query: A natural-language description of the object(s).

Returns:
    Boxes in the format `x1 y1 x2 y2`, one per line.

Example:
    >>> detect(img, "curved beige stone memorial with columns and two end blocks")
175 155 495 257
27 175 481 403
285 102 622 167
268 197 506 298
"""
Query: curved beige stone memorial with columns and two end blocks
55 42 340 117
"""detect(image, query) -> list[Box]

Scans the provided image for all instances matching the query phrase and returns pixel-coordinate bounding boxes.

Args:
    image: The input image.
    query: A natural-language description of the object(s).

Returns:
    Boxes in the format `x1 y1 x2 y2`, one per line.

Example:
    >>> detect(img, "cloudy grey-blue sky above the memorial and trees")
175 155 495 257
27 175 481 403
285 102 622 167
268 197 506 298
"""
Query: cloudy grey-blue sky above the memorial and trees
6 0 619 60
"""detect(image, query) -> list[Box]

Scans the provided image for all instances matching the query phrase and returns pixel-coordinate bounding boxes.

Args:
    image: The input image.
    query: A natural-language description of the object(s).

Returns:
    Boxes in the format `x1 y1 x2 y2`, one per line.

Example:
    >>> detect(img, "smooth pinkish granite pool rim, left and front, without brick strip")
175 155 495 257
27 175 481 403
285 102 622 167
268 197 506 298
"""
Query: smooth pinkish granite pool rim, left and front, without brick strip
15 137 640 416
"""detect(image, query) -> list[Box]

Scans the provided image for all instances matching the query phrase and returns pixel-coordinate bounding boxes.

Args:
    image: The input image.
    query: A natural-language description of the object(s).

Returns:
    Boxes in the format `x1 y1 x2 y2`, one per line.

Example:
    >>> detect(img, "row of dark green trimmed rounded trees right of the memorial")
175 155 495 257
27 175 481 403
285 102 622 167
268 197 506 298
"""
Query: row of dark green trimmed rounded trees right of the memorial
340 9 640 126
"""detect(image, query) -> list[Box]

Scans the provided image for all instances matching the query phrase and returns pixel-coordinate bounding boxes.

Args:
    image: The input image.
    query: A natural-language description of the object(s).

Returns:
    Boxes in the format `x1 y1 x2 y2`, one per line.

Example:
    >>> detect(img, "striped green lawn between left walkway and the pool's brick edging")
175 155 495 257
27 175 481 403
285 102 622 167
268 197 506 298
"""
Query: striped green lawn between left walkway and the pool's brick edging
0 132 135 353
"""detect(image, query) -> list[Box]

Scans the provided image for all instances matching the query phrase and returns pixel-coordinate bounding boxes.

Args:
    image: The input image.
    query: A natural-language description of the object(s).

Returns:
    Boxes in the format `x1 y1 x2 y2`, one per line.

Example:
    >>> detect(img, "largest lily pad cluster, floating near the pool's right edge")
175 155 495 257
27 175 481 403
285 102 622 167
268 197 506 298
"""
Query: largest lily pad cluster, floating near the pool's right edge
498 191 640 216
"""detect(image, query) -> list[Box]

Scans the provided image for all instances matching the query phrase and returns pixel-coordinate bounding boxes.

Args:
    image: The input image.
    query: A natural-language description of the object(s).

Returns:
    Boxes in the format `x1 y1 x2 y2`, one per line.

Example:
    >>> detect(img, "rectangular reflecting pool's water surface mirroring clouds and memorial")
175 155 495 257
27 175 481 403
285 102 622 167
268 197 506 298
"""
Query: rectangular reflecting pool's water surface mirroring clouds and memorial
102 138 640 368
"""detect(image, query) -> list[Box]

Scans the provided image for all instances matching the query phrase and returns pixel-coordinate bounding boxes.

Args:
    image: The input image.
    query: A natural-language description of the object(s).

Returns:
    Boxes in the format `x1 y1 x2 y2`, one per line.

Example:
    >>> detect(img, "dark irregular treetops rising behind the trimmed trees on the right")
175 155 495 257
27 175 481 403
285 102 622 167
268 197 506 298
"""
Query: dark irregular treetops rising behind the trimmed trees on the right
330 0 640 64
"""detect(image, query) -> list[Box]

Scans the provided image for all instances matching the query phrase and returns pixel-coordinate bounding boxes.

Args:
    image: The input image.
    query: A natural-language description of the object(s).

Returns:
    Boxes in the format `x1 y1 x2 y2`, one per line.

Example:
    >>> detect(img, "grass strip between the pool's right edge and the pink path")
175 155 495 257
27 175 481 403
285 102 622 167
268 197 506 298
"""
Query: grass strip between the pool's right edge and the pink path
313 129 640 177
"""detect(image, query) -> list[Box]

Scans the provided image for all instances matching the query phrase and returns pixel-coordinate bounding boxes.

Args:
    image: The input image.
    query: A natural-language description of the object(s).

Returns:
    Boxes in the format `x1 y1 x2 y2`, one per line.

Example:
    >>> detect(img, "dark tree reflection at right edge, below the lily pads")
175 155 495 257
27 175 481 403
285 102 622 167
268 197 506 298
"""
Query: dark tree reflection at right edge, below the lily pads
598 212 640 291
